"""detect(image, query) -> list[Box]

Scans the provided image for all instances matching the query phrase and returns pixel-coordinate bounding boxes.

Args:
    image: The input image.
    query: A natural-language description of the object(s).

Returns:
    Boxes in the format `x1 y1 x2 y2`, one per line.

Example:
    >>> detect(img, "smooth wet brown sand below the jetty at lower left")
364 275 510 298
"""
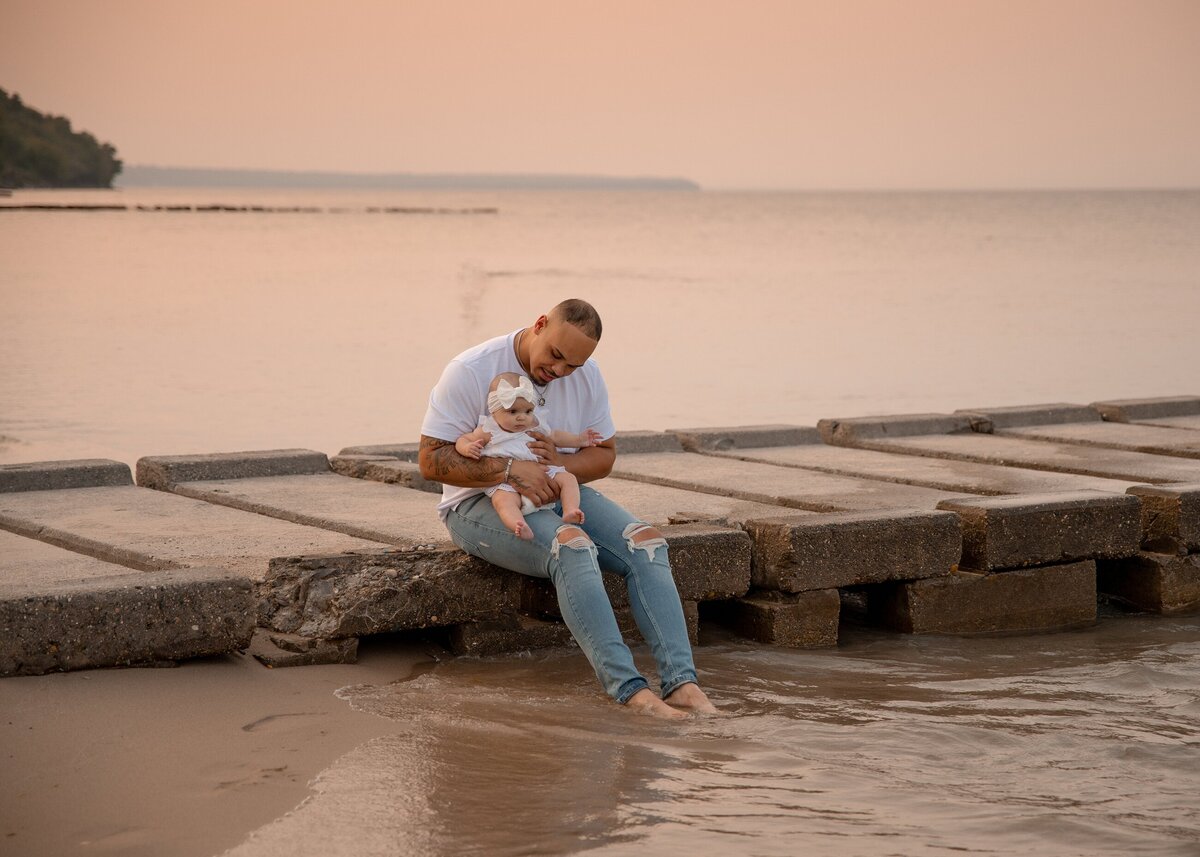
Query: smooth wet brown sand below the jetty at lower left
0 636 430 857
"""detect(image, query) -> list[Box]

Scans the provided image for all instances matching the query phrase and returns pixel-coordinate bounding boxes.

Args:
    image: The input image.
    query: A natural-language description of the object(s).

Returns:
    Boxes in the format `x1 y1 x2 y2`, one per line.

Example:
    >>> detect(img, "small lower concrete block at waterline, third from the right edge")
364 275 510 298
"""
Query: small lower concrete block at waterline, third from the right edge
704 589 841 648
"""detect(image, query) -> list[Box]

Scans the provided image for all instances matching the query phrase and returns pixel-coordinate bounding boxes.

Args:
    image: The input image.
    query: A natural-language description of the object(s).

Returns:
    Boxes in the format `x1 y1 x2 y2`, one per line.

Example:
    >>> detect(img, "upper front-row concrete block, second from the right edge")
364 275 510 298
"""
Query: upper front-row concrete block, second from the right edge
937 491 1141 571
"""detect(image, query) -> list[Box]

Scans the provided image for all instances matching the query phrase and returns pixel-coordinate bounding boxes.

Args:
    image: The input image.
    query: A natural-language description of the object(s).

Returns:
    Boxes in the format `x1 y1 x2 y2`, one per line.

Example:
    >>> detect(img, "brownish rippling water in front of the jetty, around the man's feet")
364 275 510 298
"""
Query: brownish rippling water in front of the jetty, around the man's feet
223 616 1200 857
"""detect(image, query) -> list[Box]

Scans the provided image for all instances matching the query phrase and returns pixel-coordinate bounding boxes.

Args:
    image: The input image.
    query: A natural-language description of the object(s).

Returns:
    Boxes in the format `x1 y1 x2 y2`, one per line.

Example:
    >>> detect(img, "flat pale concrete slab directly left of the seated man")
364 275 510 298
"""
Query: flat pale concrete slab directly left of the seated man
146 470 450 545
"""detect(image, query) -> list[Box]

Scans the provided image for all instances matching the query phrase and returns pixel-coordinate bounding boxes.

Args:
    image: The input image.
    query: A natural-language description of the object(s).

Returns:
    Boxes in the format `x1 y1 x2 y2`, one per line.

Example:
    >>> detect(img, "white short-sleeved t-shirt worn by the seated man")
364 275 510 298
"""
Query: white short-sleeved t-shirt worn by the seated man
421 330 617 521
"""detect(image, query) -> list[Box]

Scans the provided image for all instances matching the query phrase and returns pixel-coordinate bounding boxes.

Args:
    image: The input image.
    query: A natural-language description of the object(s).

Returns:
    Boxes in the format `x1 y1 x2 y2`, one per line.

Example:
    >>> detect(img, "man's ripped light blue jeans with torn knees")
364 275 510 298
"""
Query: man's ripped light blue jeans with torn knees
446 485 696 703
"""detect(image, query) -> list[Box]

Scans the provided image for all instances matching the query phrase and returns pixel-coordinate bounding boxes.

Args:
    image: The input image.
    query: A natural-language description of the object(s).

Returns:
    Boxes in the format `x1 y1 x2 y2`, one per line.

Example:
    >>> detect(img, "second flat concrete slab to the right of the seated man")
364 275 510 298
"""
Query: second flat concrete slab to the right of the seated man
612 453 967 511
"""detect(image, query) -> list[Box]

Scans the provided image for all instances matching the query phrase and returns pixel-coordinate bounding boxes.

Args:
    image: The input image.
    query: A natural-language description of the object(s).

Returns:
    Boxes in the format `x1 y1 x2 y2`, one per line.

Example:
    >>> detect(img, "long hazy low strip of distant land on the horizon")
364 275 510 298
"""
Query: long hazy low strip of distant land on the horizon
115 166 701 191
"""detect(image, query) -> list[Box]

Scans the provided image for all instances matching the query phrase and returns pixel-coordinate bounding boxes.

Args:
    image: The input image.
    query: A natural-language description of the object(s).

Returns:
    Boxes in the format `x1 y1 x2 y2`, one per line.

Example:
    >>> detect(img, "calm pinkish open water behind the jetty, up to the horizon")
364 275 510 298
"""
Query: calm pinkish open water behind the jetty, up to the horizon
0 188 1200 462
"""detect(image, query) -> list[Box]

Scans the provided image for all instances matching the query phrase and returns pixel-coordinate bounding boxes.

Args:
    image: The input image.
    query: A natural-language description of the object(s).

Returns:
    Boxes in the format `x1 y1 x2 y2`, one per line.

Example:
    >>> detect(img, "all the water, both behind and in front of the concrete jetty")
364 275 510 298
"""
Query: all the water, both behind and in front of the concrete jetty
0 190 1200 856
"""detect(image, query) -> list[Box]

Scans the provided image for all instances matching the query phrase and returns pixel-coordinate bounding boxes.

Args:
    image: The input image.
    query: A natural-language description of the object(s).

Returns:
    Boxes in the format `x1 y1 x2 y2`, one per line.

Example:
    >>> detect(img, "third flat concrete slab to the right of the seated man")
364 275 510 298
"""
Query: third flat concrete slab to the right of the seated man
713 444 1135 496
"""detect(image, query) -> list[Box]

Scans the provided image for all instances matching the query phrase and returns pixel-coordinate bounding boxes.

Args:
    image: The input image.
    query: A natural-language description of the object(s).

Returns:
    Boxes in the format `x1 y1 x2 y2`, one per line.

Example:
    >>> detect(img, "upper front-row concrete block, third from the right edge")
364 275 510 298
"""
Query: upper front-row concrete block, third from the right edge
745 509 962 592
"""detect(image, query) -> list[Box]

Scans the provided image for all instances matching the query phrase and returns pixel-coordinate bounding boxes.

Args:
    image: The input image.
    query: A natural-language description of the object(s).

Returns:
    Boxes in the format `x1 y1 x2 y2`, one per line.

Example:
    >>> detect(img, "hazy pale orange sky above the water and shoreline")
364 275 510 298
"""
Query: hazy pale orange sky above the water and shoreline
0 0 1200 188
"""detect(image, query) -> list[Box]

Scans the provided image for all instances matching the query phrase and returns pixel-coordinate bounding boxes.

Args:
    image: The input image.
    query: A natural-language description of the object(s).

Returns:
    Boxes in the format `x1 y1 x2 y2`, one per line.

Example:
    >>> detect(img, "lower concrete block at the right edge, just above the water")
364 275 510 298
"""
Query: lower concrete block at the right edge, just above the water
1098 552 1200 615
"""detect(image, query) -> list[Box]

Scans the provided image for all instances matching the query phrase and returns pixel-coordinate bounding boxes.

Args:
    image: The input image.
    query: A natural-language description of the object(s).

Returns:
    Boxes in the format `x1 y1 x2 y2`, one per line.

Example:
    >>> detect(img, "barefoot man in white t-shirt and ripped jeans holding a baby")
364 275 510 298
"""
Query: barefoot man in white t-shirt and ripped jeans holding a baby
419 299 716 719
